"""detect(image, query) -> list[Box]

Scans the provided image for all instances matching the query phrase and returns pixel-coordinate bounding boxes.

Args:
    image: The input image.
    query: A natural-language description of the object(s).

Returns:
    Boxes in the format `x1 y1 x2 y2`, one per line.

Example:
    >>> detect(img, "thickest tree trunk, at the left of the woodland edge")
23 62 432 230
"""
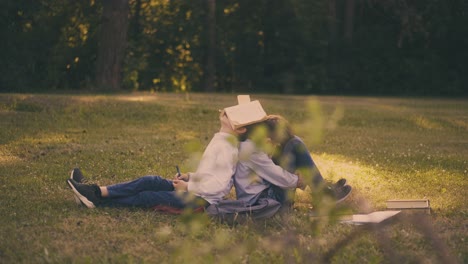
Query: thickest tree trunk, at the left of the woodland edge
96 0 129 90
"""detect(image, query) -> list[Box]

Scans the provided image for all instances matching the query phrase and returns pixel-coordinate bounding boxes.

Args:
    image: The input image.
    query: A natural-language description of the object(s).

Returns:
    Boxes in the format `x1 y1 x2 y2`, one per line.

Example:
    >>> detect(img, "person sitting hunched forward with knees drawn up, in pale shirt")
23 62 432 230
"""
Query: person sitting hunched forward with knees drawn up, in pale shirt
234 115 351 212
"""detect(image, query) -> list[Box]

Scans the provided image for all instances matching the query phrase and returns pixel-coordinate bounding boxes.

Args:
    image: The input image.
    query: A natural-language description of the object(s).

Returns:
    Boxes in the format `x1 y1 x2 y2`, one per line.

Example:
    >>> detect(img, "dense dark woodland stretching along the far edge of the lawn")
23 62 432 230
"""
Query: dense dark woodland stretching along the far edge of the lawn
0 0 468 95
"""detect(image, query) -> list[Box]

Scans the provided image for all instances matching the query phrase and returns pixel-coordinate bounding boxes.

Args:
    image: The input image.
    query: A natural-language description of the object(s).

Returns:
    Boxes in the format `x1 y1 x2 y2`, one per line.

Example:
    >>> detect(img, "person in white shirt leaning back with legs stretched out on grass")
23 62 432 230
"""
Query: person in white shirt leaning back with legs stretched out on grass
67 106 252 210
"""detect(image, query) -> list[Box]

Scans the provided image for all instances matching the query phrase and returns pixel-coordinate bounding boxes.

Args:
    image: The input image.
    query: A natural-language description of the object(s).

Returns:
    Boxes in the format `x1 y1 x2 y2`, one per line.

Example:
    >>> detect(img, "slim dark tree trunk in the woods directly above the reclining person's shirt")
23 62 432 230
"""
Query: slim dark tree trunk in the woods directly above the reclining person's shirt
204 0 216 92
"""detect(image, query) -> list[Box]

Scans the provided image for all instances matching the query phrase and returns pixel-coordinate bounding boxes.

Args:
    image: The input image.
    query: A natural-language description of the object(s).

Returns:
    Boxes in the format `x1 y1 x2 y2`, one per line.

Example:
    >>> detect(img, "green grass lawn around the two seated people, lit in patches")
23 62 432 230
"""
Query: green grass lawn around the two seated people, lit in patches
0 93 468 263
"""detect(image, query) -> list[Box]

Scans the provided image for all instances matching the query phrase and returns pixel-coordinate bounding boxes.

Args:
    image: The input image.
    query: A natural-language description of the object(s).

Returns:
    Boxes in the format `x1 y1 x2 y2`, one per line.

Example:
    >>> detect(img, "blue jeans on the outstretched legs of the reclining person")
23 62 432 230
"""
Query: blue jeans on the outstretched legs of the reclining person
98 176 207 209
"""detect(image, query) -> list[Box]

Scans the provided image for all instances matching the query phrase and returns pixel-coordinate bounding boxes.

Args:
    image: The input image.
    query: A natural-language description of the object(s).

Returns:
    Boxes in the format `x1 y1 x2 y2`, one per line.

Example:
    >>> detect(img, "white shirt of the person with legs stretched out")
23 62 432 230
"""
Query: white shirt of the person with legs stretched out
187 132 239 204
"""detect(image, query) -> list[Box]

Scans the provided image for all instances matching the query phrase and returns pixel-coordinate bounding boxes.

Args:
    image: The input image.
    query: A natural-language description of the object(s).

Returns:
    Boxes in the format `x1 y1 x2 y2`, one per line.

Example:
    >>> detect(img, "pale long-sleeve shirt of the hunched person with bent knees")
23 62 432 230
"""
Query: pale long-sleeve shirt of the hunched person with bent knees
234 140 299 204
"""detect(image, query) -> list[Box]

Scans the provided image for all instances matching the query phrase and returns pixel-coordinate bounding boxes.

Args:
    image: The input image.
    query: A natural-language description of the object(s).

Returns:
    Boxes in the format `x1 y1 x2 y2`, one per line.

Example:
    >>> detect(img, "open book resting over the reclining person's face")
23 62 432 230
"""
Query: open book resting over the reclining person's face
224 100 267 129
